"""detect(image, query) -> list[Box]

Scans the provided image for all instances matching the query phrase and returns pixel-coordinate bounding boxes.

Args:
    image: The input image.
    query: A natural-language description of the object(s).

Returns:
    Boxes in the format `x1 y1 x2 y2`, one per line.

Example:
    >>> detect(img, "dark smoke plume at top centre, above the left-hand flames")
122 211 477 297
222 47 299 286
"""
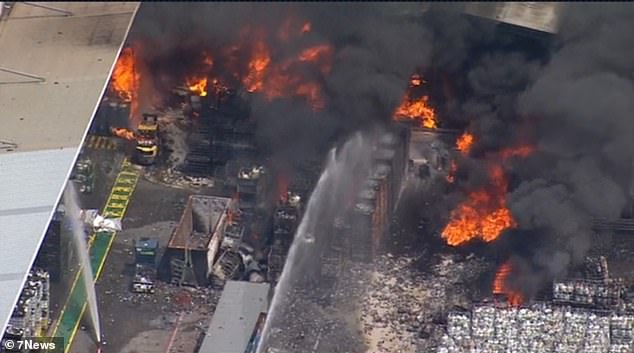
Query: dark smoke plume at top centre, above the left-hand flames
133 3 431 164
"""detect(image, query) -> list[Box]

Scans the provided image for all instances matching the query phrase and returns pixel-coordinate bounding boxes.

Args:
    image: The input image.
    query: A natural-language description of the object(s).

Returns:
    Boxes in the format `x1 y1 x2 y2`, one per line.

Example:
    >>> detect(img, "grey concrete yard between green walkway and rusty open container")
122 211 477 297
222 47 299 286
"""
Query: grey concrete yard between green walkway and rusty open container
71 155 225 353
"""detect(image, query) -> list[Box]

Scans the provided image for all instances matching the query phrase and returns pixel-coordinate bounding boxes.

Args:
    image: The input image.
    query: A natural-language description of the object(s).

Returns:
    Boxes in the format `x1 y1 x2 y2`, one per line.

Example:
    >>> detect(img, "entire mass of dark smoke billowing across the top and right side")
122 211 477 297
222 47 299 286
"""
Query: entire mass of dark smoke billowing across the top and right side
133 3 634 291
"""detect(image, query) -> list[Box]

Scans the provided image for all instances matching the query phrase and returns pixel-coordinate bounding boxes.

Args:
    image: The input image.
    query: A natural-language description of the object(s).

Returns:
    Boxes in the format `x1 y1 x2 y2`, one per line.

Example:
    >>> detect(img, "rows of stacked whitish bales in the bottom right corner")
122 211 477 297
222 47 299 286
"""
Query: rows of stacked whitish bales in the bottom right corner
438 303 634 353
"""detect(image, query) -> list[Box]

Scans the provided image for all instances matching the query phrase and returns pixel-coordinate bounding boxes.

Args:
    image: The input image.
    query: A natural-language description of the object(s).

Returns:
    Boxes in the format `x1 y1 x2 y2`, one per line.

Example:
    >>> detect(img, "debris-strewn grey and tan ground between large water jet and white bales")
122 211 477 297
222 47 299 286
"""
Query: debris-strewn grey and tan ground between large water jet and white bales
262 226 491 353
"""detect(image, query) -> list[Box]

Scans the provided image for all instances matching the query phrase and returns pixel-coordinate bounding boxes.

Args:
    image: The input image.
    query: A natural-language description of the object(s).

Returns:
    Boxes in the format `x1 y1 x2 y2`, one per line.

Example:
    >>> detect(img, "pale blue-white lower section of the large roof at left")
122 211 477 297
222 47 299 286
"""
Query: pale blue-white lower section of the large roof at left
0 148 77 330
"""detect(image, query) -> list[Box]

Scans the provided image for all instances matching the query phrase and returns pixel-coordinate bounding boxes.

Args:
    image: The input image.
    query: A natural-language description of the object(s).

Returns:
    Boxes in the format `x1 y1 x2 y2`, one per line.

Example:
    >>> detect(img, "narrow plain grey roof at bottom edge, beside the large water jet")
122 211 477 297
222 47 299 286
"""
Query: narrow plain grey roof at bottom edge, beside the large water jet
199 281 271 353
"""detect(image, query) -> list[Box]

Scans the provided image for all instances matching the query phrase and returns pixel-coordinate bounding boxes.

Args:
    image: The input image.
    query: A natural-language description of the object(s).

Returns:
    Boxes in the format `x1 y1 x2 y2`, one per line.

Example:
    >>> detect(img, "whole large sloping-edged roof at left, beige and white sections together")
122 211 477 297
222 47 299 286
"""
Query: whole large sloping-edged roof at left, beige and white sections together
0 2 139 332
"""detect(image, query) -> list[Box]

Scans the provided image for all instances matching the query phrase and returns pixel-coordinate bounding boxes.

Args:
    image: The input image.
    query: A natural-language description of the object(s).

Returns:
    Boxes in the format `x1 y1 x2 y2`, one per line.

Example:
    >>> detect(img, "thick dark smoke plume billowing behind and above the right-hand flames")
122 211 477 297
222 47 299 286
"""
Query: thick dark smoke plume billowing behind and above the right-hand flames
440 4 634 295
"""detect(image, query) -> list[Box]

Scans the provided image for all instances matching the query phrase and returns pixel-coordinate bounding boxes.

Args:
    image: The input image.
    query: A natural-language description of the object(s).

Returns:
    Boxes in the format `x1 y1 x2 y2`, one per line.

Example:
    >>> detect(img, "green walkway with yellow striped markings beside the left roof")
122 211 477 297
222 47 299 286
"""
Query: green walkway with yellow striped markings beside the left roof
51 159 140 353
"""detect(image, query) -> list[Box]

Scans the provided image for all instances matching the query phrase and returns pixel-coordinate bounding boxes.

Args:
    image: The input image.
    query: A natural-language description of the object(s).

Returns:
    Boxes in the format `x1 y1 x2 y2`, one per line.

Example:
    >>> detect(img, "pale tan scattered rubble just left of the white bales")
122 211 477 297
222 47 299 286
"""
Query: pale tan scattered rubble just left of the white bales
359 254 485 353
